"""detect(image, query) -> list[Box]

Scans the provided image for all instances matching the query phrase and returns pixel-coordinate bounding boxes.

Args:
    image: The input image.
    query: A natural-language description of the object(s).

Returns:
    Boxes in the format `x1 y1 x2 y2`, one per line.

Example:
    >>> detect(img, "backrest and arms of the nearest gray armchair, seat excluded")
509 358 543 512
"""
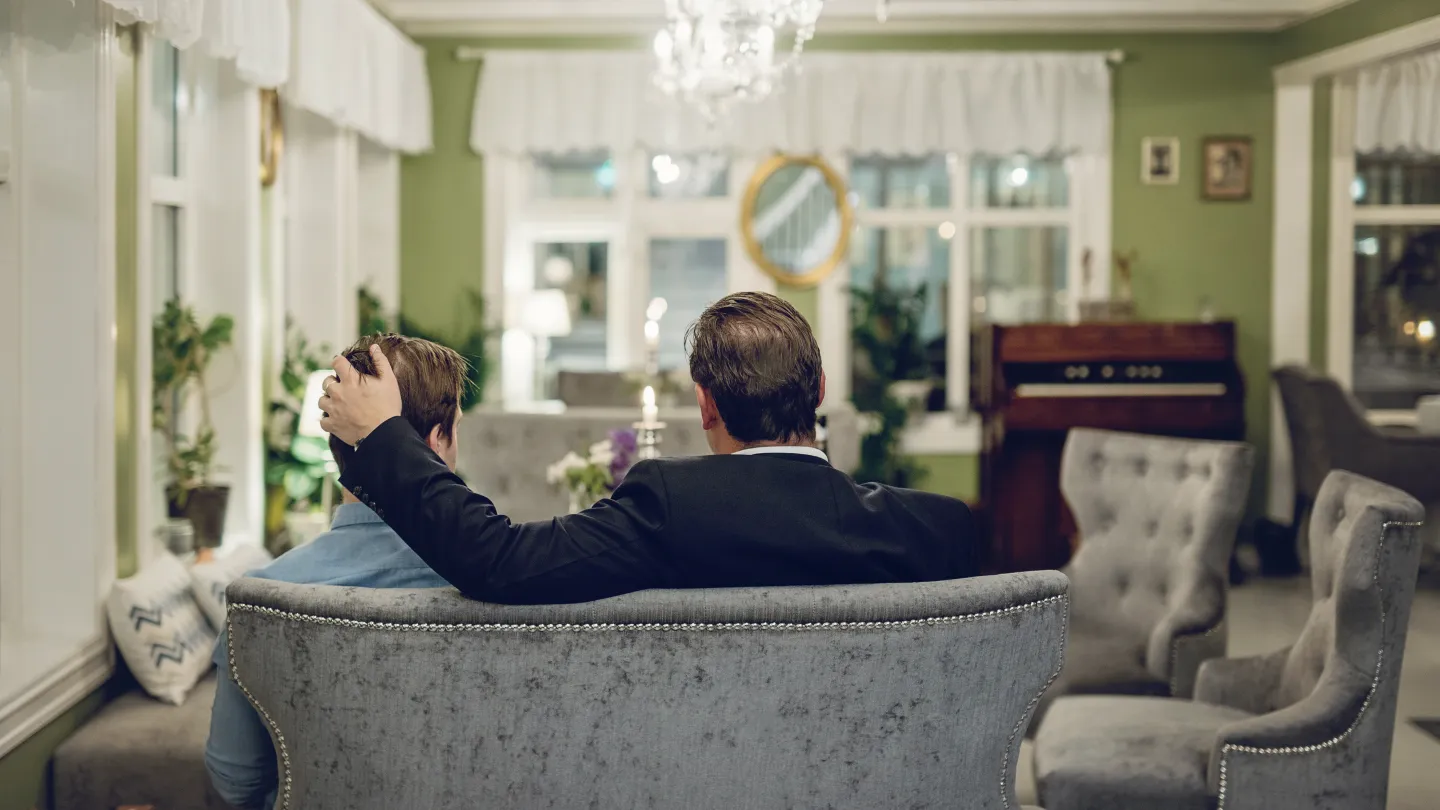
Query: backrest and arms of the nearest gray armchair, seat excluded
1197 471 1424 810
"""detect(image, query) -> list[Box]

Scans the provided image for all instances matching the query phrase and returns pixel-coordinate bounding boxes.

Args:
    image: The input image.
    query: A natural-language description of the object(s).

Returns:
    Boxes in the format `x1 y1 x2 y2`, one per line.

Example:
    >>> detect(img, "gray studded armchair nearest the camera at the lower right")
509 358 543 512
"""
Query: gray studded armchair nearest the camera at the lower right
1035 473 1424 810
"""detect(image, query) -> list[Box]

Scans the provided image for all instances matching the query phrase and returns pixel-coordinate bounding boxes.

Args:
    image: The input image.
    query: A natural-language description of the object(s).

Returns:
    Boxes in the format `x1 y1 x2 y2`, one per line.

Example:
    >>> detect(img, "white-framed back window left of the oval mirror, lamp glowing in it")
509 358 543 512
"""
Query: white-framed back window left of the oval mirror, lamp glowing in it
498 150 773 408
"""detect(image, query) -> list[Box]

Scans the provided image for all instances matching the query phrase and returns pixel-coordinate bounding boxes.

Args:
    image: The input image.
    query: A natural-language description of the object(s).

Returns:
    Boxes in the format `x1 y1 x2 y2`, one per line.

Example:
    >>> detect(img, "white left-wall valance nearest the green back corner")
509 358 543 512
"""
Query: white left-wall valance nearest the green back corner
281 0 432 153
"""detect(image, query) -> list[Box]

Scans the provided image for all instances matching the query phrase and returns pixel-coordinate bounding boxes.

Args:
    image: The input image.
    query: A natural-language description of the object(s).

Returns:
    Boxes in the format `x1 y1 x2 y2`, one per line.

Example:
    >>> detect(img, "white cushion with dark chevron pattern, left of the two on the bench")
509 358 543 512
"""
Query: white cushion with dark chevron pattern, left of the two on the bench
107 553 216 706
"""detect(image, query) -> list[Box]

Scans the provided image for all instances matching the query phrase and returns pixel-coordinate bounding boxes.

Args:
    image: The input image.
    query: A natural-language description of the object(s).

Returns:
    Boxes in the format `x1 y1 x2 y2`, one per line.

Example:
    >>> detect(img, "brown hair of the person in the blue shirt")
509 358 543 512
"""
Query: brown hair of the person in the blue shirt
330 334 469 473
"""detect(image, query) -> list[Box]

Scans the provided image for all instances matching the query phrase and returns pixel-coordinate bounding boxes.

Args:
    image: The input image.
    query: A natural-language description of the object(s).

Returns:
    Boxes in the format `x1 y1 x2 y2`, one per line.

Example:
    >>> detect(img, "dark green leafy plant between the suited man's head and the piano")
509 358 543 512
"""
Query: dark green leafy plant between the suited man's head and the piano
850 272 935 487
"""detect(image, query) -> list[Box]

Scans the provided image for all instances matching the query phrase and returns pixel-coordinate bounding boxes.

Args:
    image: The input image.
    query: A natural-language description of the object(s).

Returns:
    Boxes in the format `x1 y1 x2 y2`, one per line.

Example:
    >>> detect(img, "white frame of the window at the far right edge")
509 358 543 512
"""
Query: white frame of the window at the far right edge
1325 72 1440 425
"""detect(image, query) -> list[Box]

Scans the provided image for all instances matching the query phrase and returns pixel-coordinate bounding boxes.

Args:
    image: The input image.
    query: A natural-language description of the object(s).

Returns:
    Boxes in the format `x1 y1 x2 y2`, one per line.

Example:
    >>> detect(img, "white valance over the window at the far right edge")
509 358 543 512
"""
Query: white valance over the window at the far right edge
1355 50 1440 154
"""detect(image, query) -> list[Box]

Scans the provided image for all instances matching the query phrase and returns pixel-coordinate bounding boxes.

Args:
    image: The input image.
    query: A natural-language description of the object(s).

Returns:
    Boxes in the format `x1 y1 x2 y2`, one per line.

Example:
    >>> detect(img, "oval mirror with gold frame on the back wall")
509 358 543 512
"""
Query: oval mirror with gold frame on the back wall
740 154 854 285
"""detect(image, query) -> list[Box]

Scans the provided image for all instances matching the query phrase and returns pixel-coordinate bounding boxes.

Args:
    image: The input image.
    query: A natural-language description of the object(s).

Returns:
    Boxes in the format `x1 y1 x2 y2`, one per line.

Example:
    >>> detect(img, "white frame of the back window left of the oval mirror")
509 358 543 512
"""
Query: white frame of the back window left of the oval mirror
485 150 776 409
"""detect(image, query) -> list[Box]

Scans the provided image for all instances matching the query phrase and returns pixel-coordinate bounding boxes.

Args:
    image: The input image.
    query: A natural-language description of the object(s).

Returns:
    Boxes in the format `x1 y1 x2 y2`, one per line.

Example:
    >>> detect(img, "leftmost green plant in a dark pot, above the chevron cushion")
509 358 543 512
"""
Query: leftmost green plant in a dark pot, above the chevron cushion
153 298 235 548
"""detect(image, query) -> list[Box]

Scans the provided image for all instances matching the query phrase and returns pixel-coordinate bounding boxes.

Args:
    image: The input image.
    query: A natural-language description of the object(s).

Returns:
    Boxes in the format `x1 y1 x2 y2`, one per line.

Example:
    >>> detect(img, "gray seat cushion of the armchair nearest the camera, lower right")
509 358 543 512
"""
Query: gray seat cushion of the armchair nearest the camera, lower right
1035 698 1250 810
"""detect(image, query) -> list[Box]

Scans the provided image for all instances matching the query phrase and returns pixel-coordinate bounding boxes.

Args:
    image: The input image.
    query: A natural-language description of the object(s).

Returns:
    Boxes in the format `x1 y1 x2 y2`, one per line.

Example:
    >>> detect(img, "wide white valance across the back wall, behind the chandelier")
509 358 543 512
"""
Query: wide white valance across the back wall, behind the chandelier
471 50 1110 154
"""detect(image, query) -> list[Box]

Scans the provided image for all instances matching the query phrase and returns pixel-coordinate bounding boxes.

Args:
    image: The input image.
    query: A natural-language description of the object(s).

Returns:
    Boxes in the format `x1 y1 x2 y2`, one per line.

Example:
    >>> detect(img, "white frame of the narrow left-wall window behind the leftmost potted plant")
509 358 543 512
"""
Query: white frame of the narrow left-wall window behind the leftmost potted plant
134 26 199 568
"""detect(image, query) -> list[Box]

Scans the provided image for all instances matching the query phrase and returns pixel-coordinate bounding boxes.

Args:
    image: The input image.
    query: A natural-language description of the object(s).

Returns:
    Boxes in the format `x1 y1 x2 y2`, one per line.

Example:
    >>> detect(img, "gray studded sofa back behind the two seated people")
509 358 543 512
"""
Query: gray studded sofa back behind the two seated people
229 571 1067 810
